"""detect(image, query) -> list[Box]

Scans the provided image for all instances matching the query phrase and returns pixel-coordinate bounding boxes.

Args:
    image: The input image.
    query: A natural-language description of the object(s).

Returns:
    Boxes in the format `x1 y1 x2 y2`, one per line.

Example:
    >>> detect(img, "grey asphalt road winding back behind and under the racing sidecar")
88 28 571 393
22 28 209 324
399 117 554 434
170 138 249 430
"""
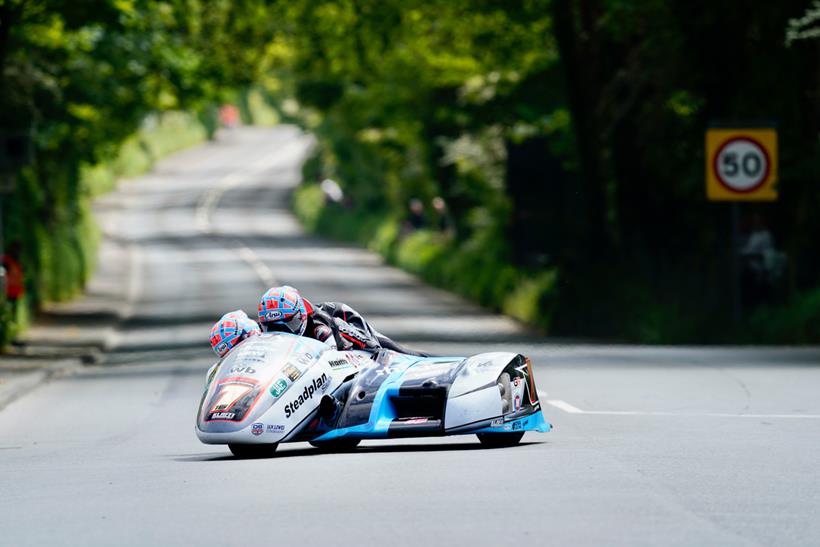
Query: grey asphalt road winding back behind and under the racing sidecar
0 127 820 546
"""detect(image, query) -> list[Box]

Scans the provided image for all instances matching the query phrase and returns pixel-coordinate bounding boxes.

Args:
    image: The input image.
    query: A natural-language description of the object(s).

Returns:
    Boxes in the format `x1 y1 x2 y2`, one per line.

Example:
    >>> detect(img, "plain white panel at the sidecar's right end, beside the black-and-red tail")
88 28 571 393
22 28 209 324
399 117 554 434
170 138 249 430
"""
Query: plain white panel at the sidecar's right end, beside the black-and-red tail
444 352 516 430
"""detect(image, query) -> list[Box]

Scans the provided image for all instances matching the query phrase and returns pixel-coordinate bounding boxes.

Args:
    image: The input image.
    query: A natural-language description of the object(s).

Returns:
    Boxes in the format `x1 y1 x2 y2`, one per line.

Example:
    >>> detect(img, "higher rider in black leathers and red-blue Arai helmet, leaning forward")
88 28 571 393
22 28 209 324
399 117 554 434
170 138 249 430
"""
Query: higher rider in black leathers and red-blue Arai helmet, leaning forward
258 285 427 357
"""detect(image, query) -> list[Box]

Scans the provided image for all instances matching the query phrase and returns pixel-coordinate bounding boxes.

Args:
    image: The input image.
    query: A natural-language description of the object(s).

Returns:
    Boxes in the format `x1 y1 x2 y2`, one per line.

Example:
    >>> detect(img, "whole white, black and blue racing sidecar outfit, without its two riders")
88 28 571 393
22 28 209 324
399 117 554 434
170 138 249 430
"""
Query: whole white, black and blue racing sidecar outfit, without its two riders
196 333 551 456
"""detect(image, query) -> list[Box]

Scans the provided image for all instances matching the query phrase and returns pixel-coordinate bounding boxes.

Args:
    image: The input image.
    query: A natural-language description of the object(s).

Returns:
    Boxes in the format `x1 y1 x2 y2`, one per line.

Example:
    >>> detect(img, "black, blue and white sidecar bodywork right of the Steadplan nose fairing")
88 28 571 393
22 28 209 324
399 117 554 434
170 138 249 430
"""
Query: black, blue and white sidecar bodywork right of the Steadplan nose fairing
316 353 551 441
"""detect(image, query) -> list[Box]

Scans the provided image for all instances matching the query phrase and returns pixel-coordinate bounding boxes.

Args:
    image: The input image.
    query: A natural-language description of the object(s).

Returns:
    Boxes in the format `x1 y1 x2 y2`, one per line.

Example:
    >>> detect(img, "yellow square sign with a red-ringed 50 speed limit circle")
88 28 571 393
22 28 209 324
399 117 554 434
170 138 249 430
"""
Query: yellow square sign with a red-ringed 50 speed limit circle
706 128 777 201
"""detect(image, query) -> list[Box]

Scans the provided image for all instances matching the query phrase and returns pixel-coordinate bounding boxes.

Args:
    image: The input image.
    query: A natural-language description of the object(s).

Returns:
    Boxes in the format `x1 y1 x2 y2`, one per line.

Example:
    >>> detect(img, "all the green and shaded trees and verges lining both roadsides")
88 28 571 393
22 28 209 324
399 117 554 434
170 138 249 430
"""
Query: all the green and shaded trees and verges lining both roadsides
0 0 820 342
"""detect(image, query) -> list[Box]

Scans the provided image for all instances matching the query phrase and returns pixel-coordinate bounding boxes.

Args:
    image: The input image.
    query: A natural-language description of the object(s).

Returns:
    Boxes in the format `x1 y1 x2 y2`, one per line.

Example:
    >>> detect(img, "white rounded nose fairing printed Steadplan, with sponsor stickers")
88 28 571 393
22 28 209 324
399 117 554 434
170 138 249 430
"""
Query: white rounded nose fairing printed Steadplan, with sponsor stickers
196 333 362 444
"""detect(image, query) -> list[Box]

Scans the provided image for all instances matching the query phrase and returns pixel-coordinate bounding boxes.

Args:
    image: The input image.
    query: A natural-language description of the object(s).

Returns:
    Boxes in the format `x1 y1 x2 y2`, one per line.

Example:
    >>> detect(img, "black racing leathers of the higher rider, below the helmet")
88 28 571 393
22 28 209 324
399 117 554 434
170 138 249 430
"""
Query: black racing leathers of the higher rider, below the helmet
305 302 427 357
